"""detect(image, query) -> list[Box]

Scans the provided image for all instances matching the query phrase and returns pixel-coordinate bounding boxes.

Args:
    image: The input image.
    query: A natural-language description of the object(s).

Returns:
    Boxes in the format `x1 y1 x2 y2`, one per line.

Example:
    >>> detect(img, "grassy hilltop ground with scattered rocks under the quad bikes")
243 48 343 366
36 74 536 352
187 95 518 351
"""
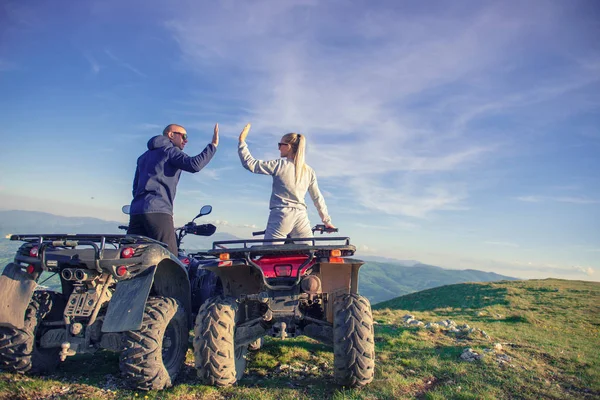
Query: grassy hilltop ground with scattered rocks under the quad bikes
0 280 600 399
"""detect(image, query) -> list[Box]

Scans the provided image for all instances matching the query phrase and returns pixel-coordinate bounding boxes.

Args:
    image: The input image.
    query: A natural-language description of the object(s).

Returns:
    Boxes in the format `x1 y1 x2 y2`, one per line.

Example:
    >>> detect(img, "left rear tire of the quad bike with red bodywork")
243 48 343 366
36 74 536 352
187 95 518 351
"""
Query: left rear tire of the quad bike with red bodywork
194 296 248 386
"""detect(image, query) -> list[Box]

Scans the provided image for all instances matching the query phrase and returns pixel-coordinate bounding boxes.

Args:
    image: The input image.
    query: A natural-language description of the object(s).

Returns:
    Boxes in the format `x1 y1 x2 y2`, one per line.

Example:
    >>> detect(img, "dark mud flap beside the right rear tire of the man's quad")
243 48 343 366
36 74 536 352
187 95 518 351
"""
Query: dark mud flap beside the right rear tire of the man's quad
102 266 156 333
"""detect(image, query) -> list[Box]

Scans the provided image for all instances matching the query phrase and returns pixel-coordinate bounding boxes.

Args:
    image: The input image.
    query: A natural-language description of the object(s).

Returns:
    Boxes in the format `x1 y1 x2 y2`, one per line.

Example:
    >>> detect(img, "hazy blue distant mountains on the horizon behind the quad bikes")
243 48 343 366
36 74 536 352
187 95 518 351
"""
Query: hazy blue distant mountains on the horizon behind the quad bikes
0 211 516 303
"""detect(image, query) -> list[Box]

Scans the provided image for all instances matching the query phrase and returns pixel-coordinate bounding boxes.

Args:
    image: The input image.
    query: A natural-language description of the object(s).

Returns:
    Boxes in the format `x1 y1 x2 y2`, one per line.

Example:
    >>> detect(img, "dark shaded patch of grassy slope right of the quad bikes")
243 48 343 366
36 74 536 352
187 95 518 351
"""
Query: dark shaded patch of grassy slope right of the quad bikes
373 283 509 315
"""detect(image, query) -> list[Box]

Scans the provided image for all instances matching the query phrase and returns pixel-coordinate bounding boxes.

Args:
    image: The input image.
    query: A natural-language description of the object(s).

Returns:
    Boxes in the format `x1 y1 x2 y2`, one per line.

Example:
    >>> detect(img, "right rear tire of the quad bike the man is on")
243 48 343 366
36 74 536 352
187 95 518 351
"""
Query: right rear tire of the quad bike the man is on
119 297 189 390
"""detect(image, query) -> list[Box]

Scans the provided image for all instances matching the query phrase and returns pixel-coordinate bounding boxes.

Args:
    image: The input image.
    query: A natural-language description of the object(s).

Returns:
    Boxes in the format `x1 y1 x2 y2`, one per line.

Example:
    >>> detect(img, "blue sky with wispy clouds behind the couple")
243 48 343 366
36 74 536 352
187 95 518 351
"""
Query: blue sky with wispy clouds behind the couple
0 0 600 280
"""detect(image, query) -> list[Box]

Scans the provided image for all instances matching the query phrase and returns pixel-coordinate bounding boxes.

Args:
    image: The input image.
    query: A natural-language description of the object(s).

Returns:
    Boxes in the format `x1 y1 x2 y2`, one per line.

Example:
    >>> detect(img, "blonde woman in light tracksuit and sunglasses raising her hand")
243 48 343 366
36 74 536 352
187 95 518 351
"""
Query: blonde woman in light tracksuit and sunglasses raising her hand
238 124 335 239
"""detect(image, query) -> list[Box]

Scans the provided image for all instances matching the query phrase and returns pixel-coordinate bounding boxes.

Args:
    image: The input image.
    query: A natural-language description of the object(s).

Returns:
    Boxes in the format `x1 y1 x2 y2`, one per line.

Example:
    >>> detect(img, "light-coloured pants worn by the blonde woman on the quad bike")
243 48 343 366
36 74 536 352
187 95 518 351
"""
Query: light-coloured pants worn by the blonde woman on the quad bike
265 207 313 244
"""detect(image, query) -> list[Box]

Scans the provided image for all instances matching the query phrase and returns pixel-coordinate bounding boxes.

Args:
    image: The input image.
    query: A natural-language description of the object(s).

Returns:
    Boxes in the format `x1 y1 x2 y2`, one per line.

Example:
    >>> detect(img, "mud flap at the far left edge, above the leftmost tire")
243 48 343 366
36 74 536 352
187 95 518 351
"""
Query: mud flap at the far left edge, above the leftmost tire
0 263 37 329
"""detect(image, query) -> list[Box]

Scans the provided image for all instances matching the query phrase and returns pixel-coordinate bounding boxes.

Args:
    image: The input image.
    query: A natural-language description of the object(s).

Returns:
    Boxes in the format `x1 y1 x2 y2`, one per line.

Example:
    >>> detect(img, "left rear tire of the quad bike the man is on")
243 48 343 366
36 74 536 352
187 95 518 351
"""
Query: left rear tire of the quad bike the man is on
0 291 64 374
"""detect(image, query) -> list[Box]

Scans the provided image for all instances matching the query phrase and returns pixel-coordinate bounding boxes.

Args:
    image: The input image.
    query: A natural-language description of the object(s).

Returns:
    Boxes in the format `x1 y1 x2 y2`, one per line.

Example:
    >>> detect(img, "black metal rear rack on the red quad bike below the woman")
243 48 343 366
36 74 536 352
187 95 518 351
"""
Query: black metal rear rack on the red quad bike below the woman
207 237 356 258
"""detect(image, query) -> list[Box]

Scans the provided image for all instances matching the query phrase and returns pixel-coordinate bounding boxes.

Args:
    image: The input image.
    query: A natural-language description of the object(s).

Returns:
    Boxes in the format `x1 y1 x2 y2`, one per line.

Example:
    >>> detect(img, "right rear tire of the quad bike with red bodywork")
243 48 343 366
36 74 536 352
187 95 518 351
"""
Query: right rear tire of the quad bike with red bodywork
333 294 375 387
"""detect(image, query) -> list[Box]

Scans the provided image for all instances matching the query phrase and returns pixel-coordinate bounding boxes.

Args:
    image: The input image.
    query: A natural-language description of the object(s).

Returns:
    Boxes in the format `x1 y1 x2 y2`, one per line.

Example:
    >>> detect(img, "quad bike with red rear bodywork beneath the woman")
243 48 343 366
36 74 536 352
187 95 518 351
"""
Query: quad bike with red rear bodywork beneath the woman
194 225 375 387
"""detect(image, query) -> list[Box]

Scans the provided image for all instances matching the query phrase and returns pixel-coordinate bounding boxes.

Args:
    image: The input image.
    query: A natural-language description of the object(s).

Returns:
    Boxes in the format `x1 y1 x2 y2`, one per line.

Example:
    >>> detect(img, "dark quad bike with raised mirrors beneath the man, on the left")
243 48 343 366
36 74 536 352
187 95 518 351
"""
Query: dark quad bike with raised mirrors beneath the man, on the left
0 206 216 389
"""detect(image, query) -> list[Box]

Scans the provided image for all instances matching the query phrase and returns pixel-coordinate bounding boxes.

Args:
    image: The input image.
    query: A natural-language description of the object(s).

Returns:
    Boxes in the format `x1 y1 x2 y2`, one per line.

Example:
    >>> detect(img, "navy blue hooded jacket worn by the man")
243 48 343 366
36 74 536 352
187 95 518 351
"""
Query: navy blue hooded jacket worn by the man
130 135 217 215
